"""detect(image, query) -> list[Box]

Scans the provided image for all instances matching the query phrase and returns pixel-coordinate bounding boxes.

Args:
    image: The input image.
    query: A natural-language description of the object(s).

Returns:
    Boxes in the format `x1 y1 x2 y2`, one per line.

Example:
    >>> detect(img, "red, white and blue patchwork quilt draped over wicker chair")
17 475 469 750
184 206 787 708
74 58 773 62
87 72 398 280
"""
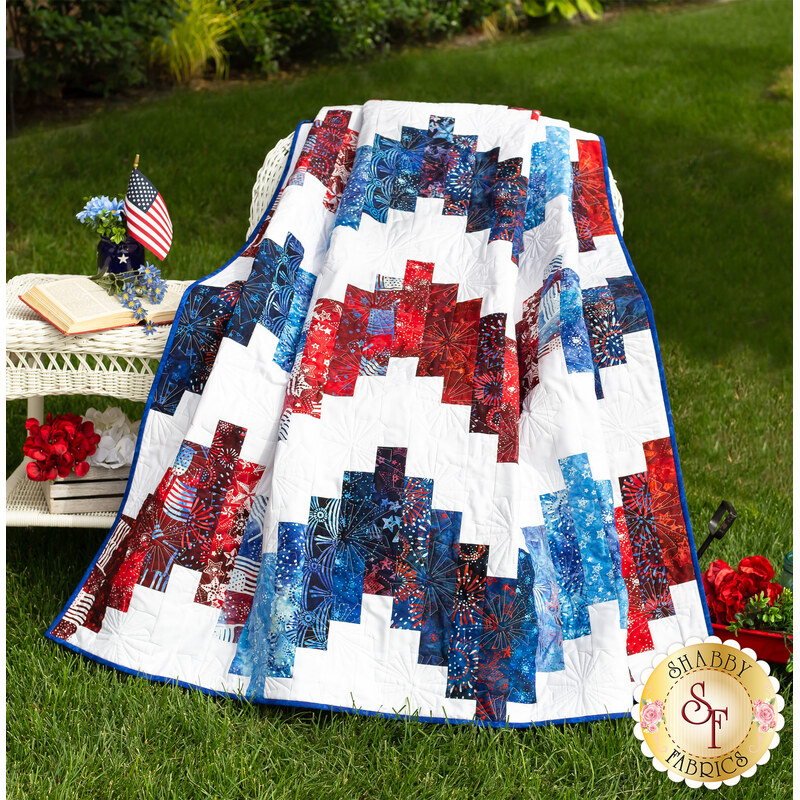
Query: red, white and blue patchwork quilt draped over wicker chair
48 101 708 725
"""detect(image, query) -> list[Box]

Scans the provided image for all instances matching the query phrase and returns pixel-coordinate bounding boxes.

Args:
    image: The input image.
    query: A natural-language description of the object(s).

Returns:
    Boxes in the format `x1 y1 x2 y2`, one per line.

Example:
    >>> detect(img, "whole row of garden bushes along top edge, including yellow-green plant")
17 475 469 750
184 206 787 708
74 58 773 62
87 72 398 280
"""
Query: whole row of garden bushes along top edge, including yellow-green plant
7 0 600 96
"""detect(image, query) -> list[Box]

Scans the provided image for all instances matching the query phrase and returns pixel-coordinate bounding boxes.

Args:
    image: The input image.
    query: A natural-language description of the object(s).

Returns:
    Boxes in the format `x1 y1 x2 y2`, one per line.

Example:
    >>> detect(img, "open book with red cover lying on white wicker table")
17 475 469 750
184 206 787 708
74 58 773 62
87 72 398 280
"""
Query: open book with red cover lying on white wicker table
19 275 186 334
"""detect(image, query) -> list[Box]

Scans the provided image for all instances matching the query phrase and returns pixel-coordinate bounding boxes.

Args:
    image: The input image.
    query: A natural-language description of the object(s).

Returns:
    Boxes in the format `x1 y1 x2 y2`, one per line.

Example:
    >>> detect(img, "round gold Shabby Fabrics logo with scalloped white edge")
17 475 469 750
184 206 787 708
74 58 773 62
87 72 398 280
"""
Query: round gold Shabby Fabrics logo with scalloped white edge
631 636 783 789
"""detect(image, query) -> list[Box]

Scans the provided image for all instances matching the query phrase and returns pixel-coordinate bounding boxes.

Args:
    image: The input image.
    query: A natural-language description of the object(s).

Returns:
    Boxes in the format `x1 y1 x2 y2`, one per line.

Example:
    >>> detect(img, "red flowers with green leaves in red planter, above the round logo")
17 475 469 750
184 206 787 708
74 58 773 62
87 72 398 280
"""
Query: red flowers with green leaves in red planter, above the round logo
703 555 793 670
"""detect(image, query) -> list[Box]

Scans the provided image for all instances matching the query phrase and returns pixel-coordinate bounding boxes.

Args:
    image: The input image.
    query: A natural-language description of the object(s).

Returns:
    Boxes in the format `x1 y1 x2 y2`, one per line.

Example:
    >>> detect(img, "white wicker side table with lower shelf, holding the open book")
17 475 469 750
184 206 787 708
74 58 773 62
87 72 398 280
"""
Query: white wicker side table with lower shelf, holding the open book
6 274 192 528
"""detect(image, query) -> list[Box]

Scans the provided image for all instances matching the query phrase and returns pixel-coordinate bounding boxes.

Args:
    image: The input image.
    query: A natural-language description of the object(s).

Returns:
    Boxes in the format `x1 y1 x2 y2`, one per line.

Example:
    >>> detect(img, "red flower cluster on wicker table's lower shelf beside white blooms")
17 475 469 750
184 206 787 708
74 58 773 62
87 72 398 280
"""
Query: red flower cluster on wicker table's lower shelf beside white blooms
22 414 100 481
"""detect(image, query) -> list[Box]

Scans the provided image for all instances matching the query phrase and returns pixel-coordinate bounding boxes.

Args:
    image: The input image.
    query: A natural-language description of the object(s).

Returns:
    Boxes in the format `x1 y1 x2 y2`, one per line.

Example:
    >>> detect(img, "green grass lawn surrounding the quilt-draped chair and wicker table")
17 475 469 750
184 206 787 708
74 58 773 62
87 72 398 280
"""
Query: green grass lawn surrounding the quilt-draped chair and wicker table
6 0 792 800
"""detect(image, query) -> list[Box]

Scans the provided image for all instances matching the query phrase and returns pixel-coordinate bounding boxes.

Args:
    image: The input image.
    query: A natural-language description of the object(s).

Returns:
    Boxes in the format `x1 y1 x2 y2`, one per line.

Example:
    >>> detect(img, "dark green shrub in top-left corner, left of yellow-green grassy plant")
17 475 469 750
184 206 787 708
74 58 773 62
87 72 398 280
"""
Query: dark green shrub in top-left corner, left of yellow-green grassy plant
6 0 175 96
